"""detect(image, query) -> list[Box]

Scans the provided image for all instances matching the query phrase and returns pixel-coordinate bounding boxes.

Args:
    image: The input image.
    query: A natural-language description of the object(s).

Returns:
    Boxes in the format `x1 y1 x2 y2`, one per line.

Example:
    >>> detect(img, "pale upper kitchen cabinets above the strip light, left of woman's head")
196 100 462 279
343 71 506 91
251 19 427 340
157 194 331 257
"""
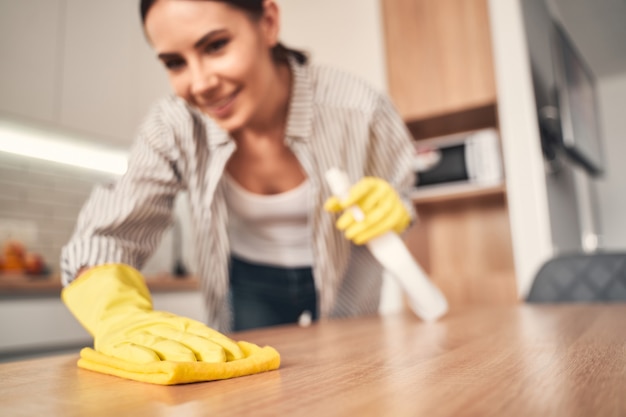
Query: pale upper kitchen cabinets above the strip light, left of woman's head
0 0 170 149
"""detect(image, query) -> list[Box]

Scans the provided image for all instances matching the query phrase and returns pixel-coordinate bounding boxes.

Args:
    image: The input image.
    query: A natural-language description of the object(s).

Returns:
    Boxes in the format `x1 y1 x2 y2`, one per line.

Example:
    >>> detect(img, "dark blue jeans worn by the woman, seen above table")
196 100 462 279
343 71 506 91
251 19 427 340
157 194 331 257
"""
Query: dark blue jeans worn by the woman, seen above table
230 257 318 331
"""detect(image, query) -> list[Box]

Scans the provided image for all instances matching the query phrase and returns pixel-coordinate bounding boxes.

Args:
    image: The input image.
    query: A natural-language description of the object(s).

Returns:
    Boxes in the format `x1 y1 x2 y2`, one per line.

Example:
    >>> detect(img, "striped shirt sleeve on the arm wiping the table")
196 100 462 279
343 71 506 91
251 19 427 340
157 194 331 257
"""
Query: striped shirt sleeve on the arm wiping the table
61 104 184 285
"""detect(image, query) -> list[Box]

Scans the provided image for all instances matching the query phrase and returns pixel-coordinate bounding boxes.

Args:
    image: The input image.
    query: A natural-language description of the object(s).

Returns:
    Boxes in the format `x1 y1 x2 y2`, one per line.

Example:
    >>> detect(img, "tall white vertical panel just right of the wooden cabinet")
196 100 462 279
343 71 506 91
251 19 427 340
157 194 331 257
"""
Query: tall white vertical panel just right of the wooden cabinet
482 0 554 298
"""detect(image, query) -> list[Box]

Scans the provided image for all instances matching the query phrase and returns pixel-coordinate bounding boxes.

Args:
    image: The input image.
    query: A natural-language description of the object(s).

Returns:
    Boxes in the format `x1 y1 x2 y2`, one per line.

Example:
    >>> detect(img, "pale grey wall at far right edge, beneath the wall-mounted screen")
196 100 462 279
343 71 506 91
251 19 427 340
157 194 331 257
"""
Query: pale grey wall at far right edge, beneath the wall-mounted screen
597 72 626 250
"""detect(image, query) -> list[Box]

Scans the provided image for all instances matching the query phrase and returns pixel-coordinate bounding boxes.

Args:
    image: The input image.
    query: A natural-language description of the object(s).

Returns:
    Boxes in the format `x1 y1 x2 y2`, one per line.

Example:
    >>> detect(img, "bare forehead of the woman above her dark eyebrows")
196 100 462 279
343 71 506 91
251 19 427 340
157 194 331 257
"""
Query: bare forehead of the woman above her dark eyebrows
145 0 251 50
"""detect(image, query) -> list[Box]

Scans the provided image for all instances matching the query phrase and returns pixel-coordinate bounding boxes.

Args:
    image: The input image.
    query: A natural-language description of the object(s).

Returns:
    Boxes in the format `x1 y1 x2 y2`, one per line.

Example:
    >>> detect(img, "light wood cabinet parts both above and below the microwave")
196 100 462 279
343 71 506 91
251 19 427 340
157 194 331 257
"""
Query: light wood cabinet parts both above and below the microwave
381 0 518 309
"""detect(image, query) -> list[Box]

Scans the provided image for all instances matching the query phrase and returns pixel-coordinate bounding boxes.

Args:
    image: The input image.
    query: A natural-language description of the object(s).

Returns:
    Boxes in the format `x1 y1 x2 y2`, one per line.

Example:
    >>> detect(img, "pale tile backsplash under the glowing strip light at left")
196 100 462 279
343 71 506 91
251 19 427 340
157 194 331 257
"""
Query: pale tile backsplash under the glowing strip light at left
0 152 188 274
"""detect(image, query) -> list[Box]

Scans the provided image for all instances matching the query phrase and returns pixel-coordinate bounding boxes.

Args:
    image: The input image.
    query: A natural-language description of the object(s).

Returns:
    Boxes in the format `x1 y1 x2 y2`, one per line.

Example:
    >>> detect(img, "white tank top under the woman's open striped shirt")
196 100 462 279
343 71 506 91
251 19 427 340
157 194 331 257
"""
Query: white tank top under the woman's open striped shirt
224 173 313 267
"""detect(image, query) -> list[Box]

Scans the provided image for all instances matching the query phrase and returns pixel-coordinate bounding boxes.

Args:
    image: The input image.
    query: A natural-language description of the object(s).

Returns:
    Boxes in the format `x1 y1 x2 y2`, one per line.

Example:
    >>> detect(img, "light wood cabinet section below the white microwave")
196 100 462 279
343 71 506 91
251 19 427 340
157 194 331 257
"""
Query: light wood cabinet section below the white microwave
405 192 518 308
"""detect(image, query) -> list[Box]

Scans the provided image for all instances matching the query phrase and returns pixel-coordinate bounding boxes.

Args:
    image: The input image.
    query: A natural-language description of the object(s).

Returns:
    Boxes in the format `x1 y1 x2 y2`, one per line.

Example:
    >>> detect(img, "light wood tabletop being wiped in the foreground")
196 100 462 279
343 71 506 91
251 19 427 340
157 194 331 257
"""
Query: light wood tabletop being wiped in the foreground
0 304 626 417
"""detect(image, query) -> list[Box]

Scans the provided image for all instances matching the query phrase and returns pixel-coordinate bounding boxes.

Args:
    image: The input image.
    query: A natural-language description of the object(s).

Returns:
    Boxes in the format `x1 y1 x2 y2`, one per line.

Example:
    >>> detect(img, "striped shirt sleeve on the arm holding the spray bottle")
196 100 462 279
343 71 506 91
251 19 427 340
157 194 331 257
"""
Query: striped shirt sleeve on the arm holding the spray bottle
370 95 416 220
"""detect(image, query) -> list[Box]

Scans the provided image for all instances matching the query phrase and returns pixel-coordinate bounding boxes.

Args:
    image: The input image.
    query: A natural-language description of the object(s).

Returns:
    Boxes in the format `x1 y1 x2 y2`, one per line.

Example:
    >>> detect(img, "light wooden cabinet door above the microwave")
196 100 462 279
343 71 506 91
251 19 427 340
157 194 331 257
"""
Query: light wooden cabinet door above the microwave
382 0 496 121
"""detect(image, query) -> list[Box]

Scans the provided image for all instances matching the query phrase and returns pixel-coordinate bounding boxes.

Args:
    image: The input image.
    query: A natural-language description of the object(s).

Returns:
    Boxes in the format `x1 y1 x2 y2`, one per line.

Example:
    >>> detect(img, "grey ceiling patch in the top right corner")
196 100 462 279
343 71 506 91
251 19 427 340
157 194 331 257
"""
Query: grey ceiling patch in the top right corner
548 0 626 77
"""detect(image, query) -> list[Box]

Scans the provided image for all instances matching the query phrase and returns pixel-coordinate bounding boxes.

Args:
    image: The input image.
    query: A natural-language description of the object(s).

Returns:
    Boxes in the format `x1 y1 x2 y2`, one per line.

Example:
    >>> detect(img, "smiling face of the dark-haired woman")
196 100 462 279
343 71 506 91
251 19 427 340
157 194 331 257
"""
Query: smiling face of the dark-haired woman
145 0 278 133
